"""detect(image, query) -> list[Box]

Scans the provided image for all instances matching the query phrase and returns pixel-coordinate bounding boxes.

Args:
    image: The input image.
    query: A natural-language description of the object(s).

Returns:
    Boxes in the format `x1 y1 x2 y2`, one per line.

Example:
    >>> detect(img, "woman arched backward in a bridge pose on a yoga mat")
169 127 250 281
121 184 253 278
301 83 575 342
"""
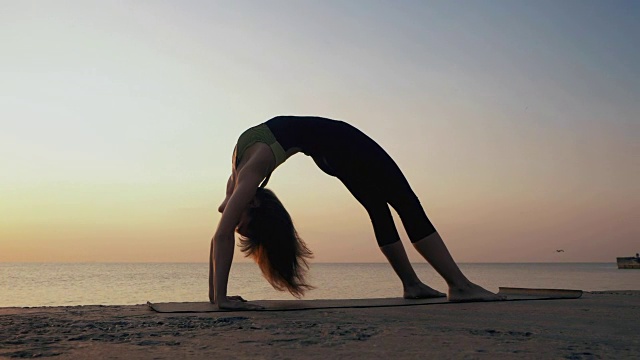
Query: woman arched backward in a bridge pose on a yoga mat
209 116 500 309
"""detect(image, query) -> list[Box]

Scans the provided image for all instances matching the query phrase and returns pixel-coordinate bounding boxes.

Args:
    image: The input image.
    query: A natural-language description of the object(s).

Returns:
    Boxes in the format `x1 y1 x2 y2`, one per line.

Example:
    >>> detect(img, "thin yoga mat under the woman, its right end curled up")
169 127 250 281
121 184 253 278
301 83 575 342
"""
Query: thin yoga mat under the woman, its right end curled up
147 287 582 313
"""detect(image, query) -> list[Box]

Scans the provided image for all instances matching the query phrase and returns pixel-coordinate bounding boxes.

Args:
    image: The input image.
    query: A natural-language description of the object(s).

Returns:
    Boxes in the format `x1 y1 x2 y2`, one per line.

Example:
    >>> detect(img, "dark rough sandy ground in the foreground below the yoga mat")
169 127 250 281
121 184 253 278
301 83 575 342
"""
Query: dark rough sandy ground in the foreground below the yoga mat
0 291 640 360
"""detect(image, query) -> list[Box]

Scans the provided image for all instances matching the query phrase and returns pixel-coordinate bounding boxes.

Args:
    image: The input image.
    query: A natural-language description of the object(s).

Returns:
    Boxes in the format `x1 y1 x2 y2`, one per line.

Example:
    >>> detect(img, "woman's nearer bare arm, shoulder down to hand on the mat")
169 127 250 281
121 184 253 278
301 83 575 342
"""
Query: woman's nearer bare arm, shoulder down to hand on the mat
209 166 264 309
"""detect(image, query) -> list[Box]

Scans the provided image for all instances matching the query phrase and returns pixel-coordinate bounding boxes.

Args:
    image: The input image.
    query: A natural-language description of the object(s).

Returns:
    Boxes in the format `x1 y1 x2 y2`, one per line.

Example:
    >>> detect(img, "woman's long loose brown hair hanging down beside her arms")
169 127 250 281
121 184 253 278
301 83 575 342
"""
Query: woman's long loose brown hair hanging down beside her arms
239 188 313 298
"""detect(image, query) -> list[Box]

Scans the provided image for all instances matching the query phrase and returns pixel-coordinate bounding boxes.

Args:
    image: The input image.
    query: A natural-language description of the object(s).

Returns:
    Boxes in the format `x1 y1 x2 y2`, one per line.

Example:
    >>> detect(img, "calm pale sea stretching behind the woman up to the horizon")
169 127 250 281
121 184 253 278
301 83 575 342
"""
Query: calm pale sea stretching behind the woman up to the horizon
0 263 640 307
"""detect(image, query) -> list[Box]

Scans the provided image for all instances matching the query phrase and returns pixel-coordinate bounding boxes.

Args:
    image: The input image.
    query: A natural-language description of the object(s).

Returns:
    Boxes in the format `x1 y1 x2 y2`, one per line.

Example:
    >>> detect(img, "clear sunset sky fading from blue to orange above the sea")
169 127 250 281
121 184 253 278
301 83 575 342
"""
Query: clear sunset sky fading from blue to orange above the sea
0 0 640 262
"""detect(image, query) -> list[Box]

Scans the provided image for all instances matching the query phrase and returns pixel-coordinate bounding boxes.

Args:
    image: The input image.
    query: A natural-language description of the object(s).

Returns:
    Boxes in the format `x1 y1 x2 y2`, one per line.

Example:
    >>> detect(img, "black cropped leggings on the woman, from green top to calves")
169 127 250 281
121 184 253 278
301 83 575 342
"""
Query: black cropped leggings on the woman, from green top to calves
266 116 436 246
